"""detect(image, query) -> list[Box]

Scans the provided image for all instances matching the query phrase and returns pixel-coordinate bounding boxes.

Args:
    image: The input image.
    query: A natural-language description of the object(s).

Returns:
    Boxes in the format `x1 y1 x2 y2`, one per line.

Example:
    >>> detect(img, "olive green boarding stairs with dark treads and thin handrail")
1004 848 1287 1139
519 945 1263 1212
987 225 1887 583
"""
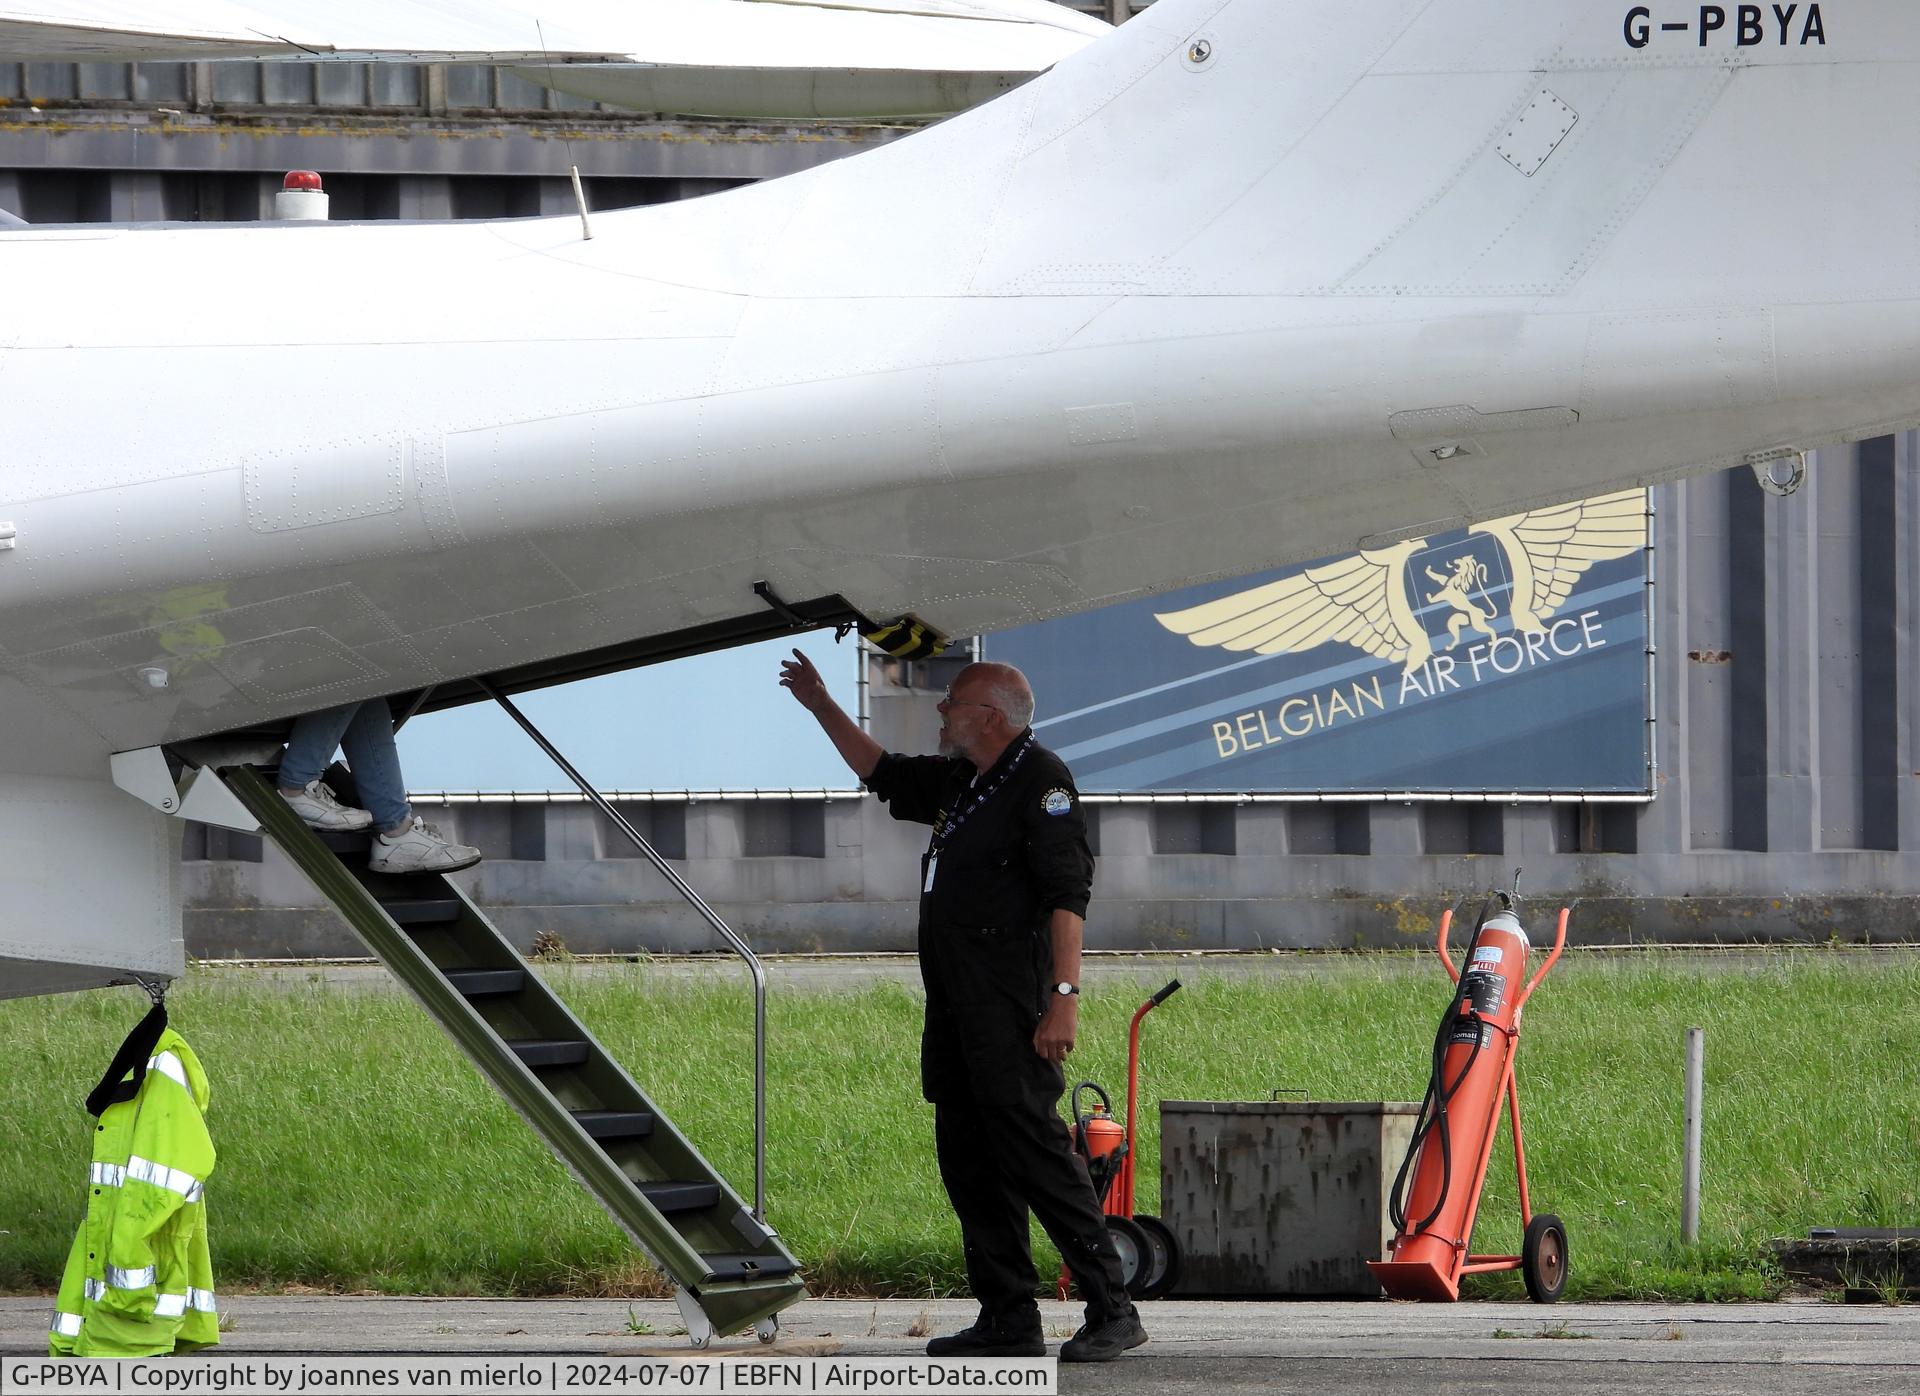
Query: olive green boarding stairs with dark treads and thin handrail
221 752 806 1348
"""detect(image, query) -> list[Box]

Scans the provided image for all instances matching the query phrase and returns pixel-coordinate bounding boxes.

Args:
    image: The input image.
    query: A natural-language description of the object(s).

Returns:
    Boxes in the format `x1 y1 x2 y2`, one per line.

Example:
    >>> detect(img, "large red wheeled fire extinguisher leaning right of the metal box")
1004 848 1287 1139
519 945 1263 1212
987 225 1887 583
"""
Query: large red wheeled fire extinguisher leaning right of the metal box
1367 893 1569 1304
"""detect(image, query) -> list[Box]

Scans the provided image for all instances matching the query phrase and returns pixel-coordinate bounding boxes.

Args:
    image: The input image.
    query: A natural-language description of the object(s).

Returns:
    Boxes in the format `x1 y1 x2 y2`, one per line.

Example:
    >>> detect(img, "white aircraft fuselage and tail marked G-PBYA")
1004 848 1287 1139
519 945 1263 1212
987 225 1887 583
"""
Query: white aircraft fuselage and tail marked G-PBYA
0 0 1920 995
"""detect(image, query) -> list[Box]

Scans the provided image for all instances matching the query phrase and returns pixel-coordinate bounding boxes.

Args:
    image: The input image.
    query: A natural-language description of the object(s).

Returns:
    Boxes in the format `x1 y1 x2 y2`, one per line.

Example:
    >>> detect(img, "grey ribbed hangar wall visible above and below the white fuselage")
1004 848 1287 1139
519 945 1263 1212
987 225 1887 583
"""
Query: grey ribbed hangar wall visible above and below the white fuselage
0 51 1920 956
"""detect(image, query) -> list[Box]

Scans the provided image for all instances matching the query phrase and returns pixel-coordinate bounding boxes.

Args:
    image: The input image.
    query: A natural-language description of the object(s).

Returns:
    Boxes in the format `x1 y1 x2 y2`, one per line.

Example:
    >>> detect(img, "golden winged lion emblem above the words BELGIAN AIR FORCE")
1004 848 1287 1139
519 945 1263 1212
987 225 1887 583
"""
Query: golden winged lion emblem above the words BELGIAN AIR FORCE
1154 490 1647 674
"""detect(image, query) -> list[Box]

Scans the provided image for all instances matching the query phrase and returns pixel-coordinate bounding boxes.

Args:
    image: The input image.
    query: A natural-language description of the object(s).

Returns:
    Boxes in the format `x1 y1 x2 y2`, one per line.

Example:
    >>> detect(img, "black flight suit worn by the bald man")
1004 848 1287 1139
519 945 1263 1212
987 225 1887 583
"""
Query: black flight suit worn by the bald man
866 732 1127 1327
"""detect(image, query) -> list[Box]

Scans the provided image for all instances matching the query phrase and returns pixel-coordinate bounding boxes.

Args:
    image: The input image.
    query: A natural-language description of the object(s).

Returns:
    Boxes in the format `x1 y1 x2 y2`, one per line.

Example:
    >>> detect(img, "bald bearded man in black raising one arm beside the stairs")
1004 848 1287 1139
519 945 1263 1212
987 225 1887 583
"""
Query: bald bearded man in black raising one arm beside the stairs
780 651 1146 1361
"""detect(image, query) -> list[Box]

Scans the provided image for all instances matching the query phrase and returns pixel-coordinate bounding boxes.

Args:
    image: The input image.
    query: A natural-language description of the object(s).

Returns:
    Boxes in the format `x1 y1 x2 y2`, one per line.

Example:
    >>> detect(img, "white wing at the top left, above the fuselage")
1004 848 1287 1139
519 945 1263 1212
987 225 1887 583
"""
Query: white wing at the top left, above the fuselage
0 0 1108 117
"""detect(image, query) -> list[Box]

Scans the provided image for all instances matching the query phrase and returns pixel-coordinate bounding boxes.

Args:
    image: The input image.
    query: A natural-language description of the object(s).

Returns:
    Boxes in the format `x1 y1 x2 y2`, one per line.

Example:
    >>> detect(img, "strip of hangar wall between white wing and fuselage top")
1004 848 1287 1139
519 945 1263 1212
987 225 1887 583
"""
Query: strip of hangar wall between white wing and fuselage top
0 56 904 223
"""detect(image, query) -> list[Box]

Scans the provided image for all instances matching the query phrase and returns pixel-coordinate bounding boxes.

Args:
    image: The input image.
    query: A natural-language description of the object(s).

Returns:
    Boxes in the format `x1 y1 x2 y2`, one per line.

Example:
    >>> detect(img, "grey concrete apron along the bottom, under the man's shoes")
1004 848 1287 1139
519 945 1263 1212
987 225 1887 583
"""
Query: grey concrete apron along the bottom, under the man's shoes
0 1296 1920 1396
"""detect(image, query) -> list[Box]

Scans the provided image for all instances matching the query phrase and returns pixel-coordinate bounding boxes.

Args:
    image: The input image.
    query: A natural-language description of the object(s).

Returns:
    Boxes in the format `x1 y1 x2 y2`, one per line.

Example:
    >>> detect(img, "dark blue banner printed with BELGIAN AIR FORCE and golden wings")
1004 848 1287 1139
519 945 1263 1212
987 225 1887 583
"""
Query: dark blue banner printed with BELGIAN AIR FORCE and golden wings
985 490 1651 795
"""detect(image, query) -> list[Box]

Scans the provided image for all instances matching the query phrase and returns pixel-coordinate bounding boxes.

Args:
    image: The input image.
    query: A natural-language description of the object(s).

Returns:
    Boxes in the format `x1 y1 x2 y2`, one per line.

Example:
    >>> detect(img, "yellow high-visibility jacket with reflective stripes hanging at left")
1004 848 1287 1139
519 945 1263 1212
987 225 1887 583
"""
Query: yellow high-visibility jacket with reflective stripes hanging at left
48 1027 221 1358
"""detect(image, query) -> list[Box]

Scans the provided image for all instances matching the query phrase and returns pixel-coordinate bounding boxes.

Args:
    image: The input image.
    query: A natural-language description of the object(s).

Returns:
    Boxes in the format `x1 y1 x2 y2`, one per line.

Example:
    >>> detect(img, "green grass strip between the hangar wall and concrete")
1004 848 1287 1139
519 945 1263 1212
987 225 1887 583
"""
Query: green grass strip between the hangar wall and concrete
0 951 1920 1300
